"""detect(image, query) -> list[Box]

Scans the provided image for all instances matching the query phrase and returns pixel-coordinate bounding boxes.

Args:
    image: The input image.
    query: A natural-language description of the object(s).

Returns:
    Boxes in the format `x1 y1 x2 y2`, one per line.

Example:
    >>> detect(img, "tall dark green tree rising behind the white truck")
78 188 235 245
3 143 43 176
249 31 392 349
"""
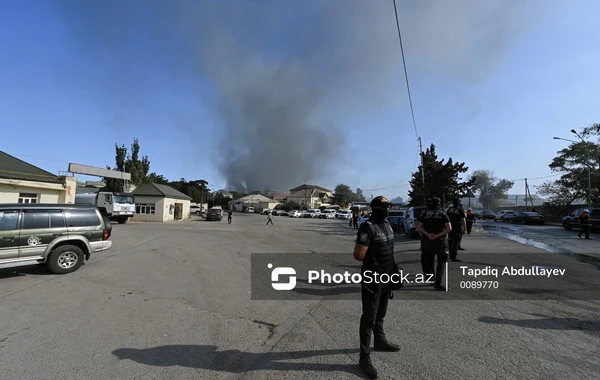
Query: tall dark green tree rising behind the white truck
103 138 151 191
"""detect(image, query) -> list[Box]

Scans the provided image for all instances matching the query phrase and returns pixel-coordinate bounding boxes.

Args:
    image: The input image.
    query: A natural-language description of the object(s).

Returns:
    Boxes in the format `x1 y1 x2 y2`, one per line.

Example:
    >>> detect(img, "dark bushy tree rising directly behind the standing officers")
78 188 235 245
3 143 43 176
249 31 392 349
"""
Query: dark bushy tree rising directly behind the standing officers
408 144 474 206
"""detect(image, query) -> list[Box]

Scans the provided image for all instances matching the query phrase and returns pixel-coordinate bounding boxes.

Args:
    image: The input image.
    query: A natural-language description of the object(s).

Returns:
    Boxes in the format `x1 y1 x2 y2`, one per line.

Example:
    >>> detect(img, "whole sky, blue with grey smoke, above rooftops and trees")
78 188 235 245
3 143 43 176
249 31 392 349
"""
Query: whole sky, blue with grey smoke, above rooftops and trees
0 0 600 198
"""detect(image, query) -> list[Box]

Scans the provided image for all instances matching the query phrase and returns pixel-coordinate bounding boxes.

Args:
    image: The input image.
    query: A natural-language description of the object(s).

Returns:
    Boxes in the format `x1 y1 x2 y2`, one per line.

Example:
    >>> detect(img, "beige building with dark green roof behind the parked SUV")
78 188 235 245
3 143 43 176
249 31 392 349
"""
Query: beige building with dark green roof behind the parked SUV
0 151 77 203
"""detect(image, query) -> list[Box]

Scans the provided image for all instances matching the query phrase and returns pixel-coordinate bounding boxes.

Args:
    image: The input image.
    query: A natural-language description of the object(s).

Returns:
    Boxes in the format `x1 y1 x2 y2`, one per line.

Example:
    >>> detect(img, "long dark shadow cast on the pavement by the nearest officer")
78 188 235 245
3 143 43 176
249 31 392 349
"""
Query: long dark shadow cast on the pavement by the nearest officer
113 345 360 375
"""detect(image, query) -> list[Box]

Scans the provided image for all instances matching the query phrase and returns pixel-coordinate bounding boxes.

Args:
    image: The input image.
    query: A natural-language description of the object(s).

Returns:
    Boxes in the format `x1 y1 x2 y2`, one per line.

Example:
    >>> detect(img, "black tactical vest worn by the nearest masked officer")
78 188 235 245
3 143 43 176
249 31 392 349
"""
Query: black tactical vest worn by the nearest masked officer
363 220 394 274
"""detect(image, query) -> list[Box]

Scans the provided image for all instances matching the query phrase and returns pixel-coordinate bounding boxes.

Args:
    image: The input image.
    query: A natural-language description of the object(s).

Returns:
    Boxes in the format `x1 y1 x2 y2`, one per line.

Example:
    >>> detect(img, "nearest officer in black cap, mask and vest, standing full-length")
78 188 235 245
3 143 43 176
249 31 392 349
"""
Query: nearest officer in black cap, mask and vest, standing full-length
354 196 400 379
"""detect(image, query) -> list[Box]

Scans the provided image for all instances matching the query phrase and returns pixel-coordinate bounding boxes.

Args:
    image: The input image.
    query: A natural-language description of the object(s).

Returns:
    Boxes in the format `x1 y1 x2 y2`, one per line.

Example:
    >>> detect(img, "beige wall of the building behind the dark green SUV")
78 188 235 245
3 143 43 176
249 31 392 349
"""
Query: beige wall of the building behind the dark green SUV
0 179 65 203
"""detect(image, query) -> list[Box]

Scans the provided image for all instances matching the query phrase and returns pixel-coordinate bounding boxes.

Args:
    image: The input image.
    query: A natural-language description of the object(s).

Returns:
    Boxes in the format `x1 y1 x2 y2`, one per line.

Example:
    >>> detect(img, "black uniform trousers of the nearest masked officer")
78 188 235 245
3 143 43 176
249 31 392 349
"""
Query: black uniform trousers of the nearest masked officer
359 272 392 355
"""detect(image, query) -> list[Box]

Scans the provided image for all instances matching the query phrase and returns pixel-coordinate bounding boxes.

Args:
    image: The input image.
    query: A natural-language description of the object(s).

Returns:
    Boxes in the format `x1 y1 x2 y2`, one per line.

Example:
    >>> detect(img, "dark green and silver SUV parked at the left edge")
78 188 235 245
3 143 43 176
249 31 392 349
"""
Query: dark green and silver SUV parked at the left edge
0 203 112 274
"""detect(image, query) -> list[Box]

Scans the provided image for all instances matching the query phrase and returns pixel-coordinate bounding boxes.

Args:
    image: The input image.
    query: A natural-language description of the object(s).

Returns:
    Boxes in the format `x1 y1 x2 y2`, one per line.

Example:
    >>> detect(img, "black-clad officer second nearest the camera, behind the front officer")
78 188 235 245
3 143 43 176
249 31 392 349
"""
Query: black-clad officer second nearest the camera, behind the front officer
417 198 452 290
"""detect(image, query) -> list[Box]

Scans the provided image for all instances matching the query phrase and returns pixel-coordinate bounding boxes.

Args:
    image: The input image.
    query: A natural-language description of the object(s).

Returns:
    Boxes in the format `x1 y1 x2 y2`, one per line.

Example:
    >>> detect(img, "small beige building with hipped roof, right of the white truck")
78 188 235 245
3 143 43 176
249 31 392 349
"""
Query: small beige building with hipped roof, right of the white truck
132 183 192 222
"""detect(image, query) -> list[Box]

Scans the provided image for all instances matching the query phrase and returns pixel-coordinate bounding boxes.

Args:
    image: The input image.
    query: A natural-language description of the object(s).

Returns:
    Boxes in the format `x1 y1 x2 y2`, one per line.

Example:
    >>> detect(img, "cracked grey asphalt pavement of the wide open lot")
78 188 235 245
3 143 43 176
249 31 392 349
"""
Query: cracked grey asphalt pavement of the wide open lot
0 214 600 380
